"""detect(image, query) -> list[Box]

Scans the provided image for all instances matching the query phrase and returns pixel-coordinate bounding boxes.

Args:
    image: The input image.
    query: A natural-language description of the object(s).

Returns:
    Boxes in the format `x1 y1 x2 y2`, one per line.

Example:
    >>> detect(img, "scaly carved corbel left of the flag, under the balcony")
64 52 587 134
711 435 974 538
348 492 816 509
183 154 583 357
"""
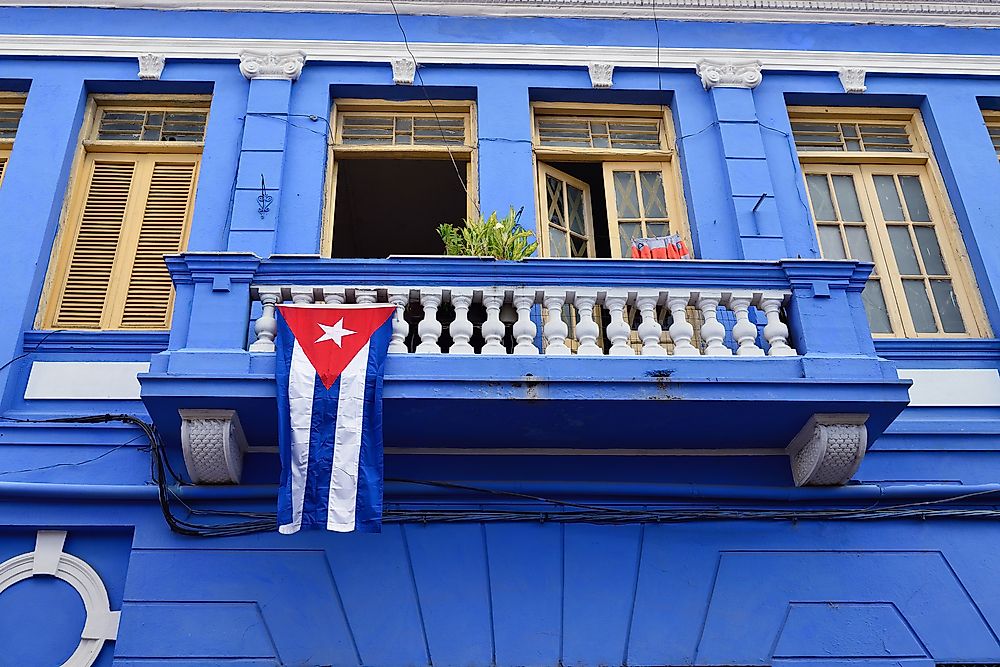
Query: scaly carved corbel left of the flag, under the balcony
178 410 247 484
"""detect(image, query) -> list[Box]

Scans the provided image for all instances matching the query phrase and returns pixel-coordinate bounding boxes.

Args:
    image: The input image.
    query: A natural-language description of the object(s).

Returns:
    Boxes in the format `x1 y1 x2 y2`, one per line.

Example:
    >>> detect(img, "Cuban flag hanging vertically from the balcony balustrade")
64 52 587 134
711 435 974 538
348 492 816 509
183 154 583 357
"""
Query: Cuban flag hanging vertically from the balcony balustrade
275 304 395 535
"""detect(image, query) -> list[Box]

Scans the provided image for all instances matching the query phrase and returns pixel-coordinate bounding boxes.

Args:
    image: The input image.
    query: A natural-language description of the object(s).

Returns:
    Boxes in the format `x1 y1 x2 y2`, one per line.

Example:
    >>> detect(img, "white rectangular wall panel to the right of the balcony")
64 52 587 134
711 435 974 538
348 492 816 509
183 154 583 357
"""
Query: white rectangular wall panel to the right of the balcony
898 368 1000 407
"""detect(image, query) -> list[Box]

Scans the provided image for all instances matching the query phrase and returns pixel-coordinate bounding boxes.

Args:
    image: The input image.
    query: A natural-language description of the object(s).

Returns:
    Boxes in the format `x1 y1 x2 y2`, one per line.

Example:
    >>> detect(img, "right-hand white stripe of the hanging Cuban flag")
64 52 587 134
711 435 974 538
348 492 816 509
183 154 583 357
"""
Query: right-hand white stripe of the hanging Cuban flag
326 343 370 533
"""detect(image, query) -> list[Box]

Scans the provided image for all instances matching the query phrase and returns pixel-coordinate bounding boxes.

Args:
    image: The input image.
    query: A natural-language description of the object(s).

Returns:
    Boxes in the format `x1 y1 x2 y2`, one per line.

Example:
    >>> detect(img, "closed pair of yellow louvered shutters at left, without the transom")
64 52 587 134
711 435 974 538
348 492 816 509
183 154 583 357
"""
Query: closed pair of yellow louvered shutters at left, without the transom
51 154 199 329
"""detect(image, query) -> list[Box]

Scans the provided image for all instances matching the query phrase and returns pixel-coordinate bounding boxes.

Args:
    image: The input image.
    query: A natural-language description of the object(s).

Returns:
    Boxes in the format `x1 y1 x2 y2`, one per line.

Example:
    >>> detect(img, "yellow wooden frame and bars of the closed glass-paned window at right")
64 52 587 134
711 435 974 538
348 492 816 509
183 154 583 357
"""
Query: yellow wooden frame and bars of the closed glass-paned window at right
789 107 990 338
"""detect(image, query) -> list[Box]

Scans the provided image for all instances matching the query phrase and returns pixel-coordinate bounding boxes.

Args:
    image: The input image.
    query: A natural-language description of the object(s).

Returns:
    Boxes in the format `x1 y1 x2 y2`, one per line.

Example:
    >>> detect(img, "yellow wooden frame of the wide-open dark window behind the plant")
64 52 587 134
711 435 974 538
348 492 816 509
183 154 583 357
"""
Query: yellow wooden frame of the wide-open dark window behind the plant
320 99 479 257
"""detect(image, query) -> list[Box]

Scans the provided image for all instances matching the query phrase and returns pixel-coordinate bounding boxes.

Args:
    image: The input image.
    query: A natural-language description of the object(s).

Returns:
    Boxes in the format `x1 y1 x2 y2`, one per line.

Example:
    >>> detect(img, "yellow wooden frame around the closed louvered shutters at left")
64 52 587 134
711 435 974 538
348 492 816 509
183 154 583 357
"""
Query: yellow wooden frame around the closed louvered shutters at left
35 94 212 332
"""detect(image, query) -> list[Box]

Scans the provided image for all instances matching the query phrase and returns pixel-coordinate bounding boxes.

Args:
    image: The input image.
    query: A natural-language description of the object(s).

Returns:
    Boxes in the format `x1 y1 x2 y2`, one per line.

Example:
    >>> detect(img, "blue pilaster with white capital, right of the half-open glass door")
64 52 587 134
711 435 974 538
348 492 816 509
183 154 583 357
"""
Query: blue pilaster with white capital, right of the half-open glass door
697 60 786 259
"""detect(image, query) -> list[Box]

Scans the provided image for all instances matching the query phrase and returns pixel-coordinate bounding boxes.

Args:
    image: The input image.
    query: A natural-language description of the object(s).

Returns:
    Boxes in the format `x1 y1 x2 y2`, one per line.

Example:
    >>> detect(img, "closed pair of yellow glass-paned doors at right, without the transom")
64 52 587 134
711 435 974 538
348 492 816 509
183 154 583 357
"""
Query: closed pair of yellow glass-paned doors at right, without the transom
803 165 979 337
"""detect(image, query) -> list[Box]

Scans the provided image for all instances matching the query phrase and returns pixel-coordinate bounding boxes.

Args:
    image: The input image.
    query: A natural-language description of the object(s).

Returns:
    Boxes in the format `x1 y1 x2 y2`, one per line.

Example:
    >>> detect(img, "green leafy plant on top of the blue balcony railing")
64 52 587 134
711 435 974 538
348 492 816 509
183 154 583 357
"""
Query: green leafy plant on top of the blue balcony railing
438 206 538 260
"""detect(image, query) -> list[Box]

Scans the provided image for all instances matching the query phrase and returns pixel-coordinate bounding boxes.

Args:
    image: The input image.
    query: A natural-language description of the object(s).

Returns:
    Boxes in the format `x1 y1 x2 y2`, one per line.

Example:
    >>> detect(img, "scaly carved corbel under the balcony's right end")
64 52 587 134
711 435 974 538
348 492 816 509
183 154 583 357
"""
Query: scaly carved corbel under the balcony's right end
785 414 868 486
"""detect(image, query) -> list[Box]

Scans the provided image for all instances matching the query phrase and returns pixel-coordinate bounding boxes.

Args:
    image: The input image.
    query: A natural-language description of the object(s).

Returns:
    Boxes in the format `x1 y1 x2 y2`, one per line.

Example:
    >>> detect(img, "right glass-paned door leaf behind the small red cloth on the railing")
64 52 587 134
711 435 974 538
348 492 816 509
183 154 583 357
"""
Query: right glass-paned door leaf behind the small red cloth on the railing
604 162 677 257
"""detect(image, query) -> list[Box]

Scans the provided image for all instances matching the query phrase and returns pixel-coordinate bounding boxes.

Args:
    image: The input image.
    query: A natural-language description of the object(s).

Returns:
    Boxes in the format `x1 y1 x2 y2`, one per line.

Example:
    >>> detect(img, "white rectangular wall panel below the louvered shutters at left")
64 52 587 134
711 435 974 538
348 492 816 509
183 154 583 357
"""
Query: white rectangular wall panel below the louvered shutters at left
24 361 149 401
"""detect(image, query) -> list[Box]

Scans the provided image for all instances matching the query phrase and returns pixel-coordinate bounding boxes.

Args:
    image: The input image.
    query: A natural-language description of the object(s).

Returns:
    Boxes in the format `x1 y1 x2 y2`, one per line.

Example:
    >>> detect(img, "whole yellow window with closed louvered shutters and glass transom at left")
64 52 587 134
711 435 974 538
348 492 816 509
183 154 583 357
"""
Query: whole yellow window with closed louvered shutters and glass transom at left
43 96 208 329
